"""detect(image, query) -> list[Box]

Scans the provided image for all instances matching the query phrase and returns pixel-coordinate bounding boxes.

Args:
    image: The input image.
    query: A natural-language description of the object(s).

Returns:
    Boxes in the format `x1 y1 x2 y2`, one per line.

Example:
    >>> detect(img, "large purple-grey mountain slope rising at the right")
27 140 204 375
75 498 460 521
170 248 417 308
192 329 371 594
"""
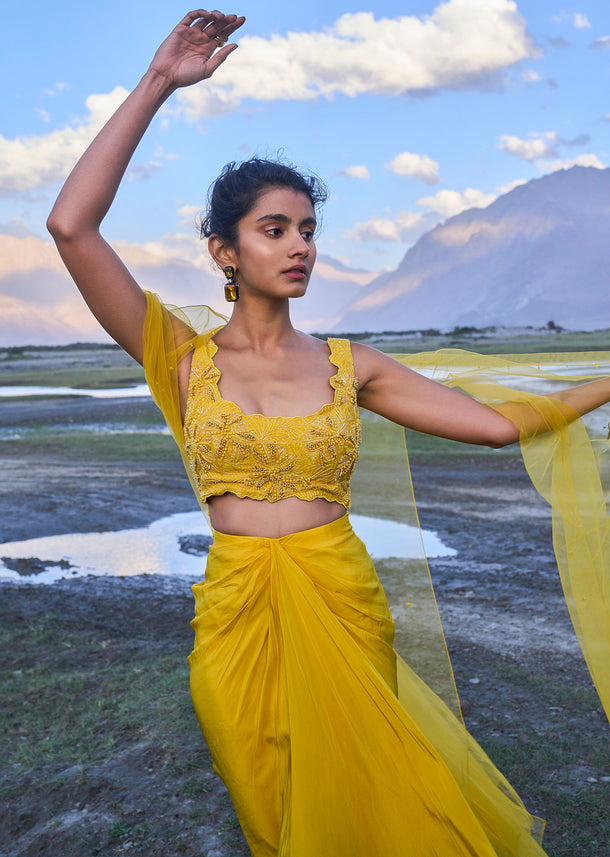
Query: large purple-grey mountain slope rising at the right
334 167 610 332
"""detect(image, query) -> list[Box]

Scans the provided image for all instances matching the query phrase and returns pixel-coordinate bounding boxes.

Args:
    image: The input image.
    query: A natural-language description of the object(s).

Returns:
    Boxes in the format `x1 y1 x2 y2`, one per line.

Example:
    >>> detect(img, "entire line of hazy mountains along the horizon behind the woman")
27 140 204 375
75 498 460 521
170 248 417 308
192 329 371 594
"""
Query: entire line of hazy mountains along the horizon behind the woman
0 167 610 346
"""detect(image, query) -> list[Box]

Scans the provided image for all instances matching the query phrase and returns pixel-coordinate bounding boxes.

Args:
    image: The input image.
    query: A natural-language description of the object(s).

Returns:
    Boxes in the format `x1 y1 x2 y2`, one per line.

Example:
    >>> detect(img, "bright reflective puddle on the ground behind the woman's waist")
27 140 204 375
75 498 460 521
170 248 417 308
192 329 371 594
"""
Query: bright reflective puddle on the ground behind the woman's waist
0 512 455 583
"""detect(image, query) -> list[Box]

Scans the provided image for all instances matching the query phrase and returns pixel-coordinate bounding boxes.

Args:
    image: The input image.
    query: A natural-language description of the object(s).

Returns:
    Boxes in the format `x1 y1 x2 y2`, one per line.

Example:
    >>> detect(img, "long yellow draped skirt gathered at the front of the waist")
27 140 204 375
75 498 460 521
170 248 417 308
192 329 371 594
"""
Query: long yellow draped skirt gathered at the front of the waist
189 515 544 857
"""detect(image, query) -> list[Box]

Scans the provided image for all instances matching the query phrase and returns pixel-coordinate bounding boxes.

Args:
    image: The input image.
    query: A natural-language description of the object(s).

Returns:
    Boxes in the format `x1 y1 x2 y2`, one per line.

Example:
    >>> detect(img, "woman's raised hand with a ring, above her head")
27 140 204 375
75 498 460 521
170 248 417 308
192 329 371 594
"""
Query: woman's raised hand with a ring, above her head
149 9 246 88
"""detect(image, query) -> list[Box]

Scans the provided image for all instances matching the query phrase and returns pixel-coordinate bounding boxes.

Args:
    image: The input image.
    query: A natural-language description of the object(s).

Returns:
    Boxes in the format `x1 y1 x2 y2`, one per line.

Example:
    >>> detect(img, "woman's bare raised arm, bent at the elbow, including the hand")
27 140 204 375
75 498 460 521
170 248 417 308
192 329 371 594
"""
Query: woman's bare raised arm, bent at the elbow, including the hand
47 9 245 362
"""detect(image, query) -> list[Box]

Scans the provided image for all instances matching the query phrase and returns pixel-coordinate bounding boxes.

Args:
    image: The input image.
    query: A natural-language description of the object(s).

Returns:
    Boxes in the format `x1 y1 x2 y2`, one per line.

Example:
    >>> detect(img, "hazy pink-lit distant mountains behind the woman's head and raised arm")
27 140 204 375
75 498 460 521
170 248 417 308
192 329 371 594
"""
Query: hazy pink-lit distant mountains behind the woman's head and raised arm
0 235 376 347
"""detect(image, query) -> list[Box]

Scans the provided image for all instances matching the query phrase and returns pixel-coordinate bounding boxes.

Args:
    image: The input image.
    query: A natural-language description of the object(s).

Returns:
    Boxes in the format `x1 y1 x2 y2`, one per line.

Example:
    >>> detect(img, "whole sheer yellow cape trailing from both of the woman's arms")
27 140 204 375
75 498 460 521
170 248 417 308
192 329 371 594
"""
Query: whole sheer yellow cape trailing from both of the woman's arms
144 293 610 717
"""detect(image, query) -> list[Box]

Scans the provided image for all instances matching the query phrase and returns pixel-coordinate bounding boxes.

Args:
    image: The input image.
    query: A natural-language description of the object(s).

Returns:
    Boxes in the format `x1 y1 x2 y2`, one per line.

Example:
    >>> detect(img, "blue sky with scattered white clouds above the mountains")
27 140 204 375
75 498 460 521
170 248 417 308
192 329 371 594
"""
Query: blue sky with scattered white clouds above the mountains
0 0 610 271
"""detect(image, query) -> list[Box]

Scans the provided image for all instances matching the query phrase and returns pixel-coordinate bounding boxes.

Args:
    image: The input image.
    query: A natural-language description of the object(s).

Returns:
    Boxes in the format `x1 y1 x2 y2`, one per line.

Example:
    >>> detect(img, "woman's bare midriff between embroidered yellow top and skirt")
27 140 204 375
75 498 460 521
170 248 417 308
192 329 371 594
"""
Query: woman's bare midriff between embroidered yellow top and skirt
208 494 345 539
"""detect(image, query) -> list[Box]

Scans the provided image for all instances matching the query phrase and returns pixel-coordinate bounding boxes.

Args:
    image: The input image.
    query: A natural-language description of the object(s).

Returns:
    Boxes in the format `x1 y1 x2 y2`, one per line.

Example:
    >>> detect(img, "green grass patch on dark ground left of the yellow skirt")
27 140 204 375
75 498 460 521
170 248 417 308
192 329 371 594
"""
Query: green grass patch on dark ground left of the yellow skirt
0 614 192 785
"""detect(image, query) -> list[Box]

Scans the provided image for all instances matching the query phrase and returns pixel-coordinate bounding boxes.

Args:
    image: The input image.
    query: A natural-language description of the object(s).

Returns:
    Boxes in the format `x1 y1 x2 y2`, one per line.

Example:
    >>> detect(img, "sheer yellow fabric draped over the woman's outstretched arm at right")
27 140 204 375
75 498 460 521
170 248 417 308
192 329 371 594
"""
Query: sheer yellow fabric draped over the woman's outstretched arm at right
397 349 610 718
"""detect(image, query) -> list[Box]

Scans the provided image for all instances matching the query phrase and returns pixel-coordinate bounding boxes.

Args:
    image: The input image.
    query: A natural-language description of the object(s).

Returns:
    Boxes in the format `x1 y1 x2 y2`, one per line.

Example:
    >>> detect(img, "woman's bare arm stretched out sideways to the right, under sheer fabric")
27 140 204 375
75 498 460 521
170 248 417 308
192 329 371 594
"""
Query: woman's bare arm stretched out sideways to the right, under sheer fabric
352 344 610 448
